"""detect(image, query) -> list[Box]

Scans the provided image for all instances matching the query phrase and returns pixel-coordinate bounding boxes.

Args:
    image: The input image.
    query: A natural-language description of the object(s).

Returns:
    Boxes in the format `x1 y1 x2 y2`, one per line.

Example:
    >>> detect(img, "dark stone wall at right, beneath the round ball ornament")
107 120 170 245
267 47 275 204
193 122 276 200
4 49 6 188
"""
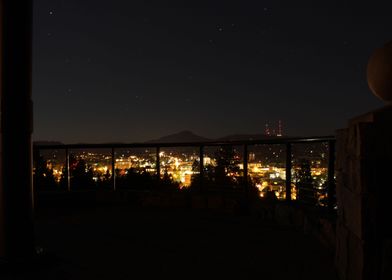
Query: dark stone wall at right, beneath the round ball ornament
335 106 392 280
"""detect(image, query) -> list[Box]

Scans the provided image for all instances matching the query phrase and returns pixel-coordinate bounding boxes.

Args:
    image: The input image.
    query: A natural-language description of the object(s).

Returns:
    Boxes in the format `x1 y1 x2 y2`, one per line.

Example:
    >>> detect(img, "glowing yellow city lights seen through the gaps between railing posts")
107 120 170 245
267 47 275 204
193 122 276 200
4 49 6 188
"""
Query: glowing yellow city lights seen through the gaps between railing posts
38 145 328 205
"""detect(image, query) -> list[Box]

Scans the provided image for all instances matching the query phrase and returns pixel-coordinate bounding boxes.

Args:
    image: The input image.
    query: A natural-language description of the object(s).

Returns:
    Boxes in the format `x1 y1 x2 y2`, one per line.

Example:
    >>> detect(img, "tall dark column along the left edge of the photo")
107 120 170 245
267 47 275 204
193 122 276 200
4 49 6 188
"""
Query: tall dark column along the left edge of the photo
0 0 34 261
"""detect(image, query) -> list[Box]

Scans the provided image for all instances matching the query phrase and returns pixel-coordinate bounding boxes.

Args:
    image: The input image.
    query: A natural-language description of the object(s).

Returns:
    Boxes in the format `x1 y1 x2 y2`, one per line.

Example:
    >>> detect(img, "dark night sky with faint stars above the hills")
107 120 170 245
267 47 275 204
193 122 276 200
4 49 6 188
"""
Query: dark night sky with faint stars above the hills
33 0 392 143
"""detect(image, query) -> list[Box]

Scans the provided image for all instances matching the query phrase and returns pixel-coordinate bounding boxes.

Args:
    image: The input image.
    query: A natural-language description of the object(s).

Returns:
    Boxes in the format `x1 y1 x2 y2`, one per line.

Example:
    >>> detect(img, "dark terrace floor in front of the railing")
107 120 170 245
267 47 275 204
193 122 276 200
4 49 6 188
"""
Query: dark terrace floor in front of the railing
0 207 336 280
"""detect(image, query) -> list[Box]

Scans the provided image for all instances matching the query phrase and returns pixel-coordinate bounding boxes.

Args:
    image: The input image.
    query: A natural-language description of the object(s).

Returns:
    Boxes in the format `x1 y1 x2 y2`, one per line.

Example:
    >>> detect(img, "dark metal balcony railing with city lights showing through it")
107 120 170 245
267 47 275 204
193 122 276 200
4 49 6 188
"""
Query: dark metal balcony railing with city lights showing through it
34 136 336 209
